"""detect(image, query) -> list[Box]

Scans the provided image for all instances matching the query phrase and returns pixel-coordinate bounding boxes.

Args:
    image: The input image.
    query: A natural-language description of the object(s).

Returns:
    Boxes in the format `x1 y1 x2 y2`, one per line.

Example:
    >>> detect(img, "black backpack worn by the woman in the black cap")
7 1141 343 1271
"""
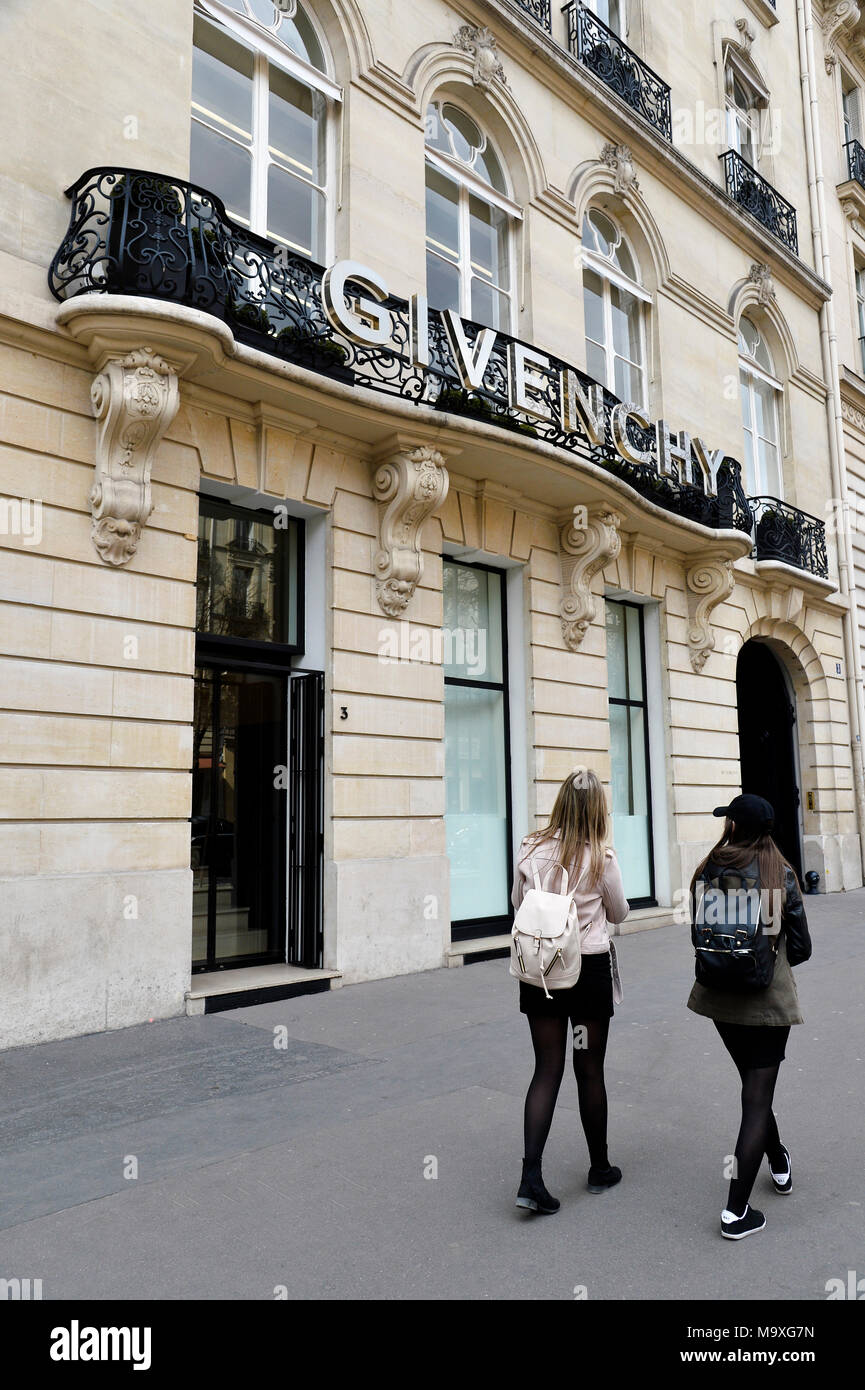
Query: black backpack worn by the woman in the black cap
691 863 779 994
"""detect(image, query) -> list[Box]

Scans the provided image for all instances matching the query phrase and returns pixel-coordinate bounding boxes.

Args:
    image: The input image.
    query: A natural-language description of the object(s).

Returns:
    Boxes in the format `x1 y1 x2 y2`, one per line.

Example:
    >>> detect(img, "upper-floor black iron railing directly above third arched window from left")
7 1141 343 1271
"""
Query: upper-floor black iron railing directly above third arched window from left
562 0 673 142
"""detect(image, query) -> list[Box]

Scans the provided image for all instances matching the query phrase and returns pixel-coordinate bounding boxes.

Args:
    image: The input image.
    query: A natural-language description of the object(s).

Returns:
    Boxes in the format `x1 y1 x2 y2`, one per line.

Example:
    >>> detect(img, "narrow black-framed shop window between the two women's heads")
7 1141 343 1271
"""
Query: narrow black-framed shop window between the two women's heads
605 599 656 908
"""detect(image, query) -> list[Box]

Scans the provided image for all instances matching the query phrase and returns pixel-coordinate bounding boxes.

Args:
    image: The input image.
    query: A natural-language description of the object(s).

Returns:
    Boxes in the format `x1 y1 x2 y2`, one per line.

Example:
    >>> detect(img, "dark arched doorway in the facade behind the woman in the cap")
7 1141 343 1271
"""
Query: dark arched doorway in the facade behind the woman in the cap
736 639 802 878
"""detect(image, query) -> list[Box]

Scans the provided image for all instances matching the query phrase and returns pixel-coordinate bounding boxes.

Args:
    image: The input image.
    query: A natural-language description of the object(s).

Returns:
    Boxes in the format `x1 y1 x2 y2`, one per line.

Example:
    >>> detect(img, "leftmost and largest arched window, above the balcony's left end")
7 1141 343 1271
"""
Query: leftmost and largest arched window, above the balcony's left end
191 0 339 260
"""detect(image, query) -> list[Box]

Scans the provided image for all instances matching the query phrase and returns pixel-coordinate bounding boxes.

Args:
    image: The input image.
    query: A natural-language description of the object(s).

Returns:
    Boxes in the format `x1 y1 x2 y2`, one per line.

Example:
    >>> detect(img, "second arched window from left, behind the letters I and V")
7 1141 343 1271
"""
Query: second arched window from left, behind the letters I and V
426 101 522 331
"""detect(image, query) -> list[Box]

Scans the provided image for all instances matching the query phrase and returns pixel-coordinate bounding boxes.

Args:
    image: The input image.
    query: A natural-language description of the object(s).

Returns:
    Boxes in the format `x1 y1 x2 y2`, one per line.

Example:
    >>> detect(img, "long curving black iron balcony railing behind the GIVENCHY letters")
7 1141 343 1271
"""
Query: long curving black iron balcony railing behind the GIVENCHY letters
49 168 752 535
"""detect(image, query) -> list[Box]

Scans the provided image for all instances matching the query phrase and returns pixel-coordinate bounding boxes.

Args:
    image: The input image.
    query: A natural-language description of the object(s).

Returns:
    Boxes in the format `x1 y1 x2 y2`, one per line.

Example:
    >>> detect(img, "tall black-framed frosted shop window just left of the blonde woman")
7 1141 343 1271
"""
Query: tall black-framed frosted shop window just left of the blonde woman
442 559 513 941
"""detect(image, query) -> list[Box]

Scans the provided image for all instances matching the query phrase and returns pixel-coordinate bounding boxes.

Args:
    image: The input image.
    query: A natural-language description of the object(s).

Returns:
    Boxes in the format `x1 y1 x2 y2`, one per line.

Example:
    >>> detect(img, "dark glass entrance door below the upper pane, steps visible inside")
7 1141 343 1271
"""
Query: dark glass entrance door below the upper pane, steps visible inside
192 666 288 970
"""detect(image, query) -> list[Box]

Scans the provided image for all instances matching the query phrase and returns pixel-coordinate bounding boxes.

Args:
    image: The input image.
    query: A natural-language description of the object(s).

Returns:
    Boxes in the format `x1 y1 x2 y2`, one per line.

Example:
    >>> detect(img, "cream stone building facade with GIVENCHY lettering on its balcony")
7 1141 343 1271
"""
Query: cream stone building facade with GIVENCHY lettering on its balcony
0 0 865 1047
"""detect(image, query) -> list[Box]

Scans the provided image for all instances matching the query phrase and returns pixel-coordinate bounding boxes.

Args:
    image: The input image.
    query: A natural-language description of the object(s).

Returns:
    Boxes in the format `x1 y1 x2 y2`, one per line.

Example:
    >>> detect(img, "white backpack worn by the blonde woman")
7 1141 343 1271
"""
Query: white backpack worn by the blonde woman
510 865 583 999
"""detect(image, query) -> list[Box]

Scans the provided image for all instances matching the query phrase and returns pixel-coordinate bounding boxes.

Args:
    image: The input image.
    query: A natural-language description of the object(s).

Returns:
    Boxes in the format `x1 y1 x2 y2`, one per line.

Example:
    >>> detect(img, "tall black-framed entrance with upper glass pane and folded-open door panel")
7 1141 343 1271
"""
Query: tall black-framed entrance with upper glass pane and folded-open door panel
191 496 310 973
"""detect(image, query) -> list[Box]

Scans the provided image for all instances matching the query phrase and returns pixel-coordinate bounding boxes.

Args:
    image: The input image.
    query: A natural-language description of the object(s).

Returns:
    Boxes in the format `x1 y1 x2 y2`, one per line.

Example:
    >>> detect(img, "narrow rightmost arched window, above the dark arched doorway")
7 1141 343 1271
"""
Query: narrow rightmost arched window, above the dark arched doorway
738 316 783 498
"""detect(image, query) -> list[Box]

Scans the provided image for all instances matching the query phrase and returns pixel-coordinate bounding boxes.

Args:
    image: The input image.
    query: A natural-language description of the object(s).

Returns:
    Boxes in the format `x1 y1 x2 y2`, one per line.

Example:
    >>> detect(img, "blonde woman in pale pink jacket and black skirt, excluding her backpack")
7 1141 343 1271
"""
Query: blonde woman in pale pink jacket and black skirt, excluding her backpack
510 770 629 1213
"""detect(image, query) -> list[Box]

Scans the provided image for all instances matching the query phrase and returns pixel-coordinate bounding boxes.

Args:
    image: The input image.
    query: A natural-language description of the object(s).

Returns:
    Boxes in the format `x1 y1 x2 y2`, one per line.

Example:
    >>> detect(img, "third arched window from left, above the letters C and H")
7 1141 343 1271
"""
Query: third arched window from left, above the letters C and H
583 209 651 407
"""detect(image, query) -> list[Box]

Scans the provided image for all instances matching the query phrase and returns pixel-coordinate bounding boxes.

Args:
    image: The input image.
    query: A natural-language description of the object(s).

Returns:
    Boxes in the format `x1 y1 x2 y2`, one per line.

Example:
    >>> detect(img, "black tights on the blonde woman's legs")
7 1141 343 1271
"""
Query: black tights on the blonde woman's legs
524 1015 609 1169
